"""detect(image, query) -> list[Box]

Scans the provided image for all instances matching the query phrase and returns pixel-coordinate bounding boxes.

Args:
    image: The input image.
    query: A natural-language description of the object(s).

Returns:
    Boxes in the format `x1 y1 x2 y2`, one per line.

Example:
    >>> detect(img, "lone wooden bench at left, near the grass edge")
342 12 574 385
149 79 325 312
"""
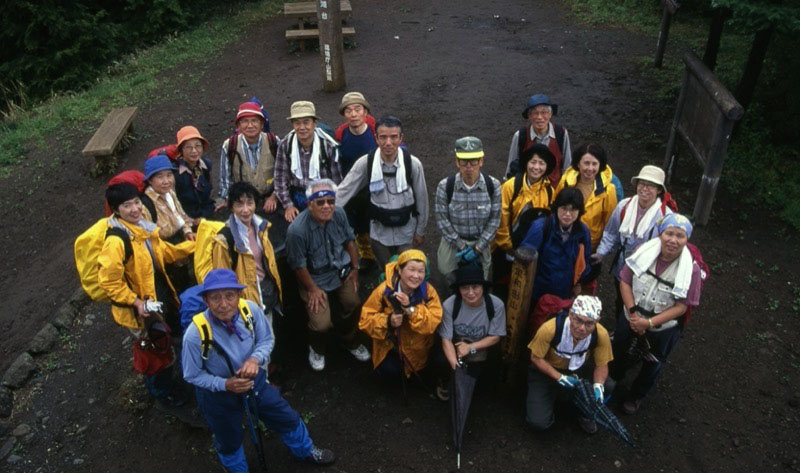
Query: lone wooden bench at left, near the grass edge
82 107 139 176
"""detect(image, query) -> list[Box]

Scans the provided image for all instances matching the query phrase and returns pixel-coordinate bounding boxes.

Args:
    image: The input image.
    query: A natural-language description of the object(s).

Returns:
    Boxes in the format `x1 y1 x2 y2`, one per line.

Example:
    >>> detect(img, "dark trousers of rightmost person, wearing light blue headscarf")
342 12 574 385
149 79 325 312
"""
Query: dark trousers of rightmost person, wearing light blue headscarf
611 315 681 400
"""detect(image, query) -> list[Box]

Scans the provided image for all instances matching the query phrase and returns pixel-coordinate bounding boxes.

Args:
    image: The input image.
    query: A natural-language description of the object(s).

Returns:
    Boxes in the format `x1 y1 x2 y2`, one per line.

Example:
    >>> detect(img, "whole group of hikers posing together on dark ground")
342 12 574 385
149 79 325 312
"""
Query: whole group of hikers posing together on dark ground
76 92 702 472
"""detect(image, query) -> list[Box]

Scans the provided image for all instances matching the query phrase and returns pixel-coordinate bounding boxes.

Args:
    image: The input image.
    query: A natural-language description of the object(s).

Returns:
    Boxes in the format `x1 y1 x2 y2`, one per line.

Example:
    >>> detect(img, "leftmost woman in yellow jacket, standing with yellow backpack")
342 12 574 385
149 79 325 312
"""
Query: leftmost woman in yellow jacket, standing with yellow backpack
97 184 195 412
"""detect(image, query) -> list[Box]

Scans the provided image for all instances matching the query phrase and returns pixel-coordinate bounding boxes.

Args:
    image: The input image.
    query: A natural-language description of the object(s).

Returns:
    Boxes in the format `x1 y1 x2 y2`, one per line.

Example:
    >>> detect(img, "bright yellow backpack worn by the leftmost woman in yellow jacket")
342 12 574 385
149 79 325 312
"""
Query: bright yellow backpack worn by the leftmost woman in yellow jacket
74 218 133 302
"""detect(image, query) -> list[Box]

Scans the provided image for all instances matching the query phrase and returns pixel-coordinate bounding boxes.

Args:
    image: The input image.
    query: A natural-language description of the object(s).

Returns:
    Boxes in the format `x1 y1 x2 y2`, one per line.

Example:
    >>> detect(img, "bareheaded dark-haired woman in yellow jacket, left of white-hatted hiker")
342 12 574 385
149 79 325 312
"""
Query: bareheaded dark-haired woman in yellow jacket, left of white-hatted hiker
556 143 617 294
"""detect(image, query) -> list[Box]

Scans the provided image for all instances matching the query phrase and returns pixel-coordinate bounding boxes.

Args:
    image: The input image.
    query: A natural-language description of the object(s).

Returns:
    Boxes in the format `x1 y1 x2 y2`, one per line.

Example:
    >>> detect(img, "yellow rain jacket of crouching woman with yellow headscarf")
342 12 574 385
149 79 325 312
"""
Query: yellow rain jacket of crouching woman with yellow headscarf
358 262 442 376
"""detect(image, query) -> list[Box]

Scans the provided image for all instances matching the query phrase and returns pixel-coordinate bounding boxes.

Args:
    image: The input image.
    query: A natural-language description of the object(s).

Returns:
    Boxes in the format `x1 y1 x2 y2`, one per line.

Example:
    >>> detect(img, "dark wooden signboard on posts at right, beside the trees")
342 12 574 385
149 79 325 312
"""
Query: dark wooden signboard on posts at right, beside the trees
664 51 744 225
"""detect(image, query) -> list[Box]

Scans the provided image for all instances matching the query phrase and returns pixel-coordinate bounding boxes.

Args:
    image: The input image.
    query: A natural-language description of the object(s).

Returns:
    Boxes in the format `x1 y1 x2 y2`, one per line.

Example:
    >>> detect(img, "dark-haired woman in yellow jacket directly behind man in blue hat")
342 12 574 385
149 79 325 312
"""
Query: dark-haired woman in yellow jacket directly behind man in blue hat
211 181 282 324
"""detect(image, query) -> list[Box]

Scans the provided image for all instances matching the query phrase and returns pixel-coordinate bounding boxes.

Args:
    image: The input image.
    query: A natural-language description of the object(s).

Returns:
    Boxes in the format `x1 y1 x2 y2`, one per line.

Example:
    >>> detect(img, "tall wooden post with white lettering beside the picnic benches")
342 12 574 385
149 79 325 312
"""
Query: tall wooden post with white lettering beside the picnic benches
317 0 345 92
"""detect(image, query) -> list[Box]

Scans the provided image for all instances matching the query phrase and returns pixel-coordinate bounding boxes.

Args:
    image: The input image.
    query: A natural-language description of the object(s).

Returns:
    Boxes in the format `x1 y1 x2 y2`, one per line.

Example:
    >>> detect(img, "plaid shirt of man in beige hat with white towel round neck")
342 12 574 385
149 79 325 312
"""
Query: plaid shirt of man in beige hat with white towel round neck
275 131 342 208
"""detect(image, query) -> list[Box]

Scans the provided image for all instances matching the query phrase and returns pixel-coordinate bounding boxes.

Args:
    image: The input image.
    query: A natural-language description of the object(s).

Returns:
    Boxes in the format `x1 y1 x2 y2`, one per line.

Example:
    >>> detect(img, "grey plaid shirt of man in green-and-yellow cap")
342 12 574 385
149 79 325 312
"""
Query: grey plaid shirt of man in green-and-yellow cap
435 173 502 251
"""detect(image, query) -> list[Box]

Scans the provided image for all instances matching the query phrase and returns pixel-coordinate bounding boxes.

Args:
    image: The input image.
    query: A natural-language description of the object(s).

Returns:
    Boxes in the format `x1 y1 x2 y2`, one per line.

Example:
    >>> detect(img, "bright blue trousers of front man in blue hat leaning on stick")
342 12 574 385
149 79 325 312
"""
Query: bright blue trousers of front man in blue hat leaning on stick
195 370 312 464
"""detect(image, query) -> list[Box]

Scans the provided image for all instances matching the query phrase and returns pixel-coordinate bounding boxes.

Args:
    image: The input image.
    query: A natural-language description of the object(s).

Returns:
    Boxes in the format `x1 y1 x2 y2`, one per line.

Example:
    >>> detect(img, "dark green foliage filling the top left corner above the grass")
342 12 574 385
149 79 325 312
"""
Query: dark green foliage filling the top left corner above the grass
0 0 247 112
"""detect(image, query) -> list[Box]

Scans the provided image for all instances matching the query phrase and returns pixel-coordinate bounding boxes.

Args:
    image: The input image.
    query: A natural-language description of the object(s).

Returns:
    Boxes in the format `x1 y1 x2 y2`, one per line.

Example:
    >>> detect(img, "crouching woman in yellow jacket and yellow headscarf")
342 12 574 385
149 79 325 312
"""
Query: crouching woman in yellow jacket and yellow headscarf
358 250 442 377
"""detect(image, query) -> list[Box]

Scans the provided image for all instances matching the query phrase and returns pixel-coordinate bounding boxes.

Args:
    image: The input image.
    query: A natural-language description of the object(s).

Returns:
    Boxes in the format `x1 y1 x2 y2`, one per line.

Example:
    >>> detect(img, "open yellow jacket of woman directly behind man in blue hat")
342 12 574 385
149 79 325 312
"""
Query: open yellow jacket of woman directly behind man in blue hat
211 220 283 304
